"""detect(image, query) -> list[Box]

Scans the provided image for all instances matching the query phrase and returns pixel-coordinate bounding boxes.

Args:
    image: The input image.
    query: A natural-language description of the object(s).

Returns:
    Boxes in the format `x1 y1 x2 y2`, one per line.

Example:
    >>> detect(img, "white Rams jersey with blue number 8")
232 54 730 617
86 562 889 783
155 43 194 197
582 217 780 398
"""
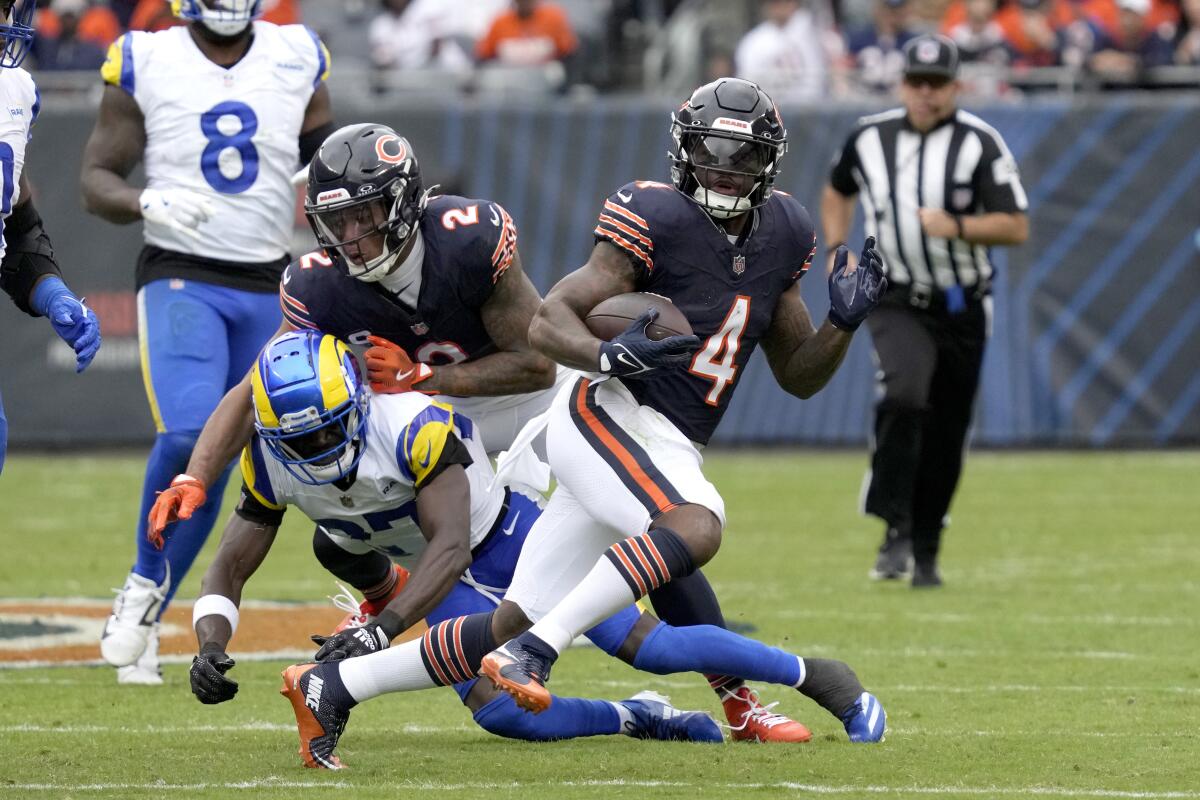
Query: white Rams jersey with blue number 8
101 22 329 263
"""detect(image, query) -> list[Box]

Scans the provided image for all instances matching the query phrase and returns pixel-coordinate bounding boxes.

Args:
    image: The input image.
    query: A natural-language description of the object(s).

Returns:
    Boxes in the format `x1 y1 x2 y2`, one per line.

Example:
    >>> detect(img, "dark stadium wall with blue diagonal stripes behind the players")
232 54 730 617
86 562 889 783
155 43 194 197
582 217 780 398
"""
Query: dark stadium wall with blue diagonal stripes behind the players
0 96 1200 446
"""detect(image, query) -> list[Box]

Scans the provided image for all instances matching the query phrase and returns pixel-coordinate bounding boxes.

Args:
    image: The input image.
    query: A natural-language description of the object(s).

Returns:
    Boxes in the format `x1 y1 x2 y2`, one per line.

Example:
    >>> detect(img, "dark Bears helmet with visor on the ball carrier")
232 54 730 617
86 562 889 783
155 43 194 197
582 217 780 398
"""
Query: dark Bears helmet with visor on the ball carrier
667 78 787 219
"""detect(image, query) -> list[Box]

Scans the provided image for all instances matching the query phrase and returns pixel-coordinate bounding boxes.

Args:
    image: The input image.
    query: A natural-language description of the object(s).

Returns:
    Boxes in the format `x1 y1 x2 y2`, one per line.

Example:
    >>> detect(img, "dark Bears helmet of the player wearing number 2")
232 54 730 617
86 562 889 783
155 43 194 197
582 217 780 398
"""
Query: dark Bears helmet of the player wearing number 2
304 122 430 286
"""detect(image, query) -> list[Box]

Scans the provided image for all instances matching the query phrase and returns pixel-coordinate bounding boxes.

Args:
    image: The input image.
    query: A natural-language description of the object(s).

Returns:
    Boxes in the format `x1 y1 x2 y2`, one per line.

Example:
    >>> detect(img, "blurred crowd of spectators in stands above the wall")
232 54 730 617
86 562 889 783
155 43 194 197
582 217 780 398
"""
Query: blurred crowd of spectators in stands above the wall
18 0 1200 94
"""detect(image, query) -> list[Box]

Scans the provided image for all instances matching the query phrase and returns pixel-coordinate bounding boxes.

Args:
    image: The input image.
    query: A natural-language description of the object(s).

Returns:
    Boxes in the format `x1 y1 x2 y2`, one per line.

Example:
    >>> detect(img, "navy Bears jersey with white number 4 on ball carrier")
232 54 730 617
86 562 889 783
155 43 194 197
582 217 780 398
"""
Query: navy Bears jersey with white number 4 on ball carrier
594 181 816 444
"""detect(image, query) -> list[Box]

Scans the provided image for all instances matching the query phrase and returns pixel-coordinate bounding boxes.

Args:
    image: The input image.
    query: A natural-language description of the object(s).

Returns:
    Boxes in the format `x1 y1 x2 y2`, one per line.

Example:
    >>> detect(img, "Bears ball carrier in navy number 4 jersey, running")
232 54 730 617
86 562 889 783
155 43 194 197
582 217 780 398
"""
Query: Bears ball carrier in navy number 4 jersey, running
472 78 887 741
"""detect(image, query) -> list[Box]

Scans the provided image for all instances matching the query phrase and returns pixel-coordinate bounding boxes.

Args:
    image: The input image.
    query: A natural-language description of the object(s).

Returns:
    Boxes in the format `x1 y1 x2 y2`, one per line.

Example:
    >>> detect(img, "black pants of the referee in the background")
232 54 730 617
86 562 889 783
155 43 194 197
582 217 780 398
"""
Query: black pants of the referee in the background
865 293 988 563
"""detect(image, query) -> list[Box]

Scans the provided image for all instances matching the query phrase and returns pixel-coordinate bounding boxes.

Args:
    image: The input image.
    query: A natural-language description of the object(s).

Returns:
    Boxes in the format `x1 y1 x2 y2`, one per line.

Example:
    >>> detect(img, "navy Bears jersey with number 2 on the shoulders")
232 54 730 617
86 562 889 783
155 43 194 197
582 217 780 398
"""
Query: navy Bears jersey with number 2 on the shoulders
280 194 517 363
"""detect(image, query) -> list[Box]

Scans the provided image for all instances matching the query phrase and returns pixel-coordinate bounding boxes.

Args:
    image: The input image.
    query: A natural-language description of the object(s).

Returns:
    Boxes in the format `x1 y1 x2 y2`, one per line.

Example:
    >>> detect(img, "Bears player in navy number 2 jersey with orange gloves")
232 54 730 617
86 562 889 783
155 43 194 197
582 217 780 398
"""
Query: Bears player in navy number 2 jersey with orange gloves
148 124 559 657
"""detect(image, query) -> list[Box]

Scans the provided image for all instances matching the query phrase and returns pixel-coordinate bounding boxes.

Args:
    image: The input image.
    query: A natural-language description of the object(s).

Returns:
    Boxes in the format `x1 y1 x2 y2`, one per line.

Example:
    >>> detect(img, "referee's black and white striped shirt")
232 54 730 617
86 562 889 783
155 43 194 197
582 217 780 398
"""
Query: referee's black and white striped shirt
829 108 1028 289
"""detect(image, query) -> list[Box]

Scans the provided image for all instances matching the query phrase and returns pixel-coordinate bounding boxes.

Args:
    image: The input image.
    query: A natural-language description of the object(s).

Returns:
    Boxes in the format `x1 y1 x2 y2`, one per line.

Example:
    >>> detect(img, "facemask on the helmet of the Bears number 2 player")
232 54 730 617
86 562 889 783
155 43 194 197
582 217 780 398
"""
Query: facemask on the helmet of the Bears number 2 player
305 176 428 282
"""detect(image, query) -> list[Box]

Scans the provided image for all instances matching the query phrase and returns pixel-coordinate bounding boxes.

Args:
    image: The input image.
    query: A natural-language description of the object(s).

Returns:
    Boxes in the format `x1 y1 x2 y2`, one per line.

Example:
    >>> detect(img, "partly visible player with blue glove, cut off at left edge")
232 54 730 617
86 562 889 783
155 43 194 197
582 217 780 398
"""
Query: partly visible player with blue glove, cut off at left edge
0 0 100 470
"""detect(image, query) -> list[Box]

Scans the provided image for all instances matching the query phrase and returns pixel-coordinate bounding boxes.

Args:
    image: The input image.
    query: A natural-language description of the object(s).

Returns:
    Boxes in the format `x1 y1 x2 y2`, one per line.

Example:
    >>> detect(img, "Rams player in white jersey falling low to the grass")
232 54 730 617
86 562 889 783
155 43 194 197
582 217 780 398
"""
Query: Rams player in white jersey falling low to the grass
182 331 721 768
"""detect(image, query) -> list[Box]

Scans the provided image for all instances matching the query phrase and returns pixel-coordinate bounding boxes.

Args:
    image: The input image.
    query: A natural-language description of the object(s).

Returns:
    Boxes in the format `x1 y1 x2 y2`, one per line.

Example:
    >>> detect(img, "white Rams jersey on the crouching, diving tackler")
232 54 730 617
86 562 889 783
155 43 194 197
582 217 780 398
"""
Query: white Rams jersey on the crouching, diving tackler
241 392 504 569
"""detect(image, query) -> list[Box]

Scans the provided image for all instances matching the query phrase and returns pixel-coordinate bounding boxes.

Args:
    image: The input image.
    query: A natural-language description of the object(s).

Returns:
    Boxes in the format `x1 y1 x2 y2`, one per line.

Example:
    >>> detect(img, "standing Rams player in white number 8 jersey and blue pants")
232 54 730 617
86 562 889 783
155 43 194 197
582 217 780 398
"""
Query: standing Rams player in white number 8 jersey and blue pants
82 0 332 684
